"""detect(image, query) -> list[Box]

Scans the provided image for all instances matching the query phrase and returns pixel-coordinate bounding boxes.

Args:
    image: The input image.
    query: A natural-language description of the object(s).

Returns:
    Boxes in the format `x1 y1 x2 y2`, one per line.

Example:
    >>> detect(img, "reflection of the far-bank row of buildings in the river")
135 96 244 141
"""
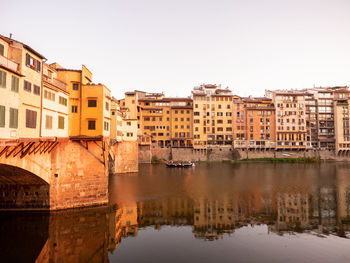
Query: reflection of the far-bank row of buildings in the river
111 164 350 243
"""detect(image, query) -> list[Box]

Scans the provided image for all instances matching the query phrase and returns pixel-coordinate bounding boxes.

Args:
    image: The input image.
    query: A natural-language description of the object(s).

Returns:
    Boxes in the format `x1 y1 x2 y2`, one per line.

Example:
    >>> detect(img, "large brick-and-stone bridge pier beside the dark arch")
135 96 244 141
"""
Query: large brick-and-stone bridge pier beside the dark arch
50 141 108 210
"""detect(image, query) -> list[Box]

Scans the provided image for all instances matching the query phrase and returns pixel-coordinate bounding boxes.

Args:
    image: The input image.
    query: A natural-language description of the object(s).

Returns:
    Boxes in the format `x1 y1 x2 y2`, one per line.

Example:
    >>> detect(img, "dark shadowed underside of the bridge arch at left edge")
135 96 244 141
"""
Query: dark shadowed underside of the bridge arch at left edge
0 164 50 210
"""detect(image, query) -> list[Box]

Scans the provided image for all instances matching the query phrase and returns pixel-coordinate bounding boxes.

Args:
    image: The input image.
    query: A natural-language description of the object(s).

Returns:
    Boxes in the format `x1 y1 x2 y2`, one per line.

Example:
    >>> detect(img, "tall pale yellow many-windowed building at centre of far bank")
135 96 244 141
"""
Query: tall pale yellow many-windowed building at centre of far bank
192 84 233 149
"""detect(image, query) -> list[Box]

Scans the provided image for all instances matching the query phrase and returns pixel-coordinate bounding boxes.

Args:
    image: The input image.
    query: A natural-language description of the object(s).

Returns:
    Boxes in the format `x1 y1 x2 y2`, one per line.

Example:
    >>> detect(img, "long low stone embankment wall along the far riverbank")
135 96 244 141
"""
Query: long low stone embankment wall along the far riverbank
139 146 350 163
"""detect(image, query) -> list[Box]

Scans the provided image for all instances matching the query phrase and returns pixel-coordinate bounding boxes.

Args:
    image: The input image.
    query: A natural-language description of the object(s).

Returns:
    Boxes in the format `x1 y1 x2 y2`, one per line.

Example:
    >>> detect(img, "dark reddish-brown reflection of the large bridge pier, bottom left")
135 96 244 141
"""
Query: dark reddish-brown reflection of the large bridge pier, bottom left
36 208 108 262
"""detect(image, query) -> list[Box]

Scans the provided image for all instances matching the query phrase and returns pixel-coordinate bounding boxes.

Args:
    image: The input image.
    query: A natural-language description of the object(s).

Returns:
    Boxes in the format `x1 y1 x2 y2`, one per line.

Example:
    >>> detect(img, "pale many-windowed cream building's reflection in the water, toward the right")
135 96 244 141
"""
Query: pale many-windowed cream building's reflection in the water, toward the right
276 192 309 231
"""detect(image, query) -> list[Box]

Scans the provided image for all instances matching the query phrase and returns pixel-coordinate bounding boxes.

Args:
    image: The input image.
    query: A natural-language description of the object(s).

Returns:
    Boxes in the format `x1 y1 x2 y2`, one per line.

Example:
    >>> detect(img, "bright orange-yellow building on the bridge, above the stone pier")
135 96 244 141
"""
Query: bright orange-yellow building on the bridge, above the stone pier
52 63 111 137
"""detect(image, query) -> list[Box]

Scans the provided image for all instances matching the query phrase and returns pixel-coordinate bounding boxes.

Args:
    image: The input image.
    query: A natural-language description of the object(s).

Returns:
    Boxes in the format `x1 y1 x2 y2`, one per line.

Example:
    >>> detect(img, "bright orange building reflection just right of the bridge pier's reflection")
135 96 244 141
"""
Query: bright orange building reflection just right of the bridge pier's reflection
108 202 138 254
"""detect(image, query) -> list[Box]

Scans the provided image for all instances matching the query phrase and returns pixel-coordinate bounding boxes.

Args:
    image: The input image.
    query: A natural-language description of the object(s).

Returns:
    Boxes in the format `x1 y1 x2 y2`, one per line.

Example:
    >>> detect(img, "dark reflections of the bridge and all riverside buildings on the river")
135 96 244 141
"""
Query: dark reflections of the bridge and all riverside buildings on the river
0 163 350 262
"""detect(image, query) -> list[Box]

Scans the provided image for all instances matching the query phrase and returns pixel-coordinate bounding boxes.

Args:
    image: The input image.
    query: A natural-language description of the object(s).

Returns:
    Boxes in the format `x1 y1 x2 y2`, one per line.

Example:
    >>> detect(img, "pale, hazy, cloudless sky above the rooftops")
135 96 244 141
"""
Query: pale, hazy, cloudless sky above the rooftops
0 0 350 98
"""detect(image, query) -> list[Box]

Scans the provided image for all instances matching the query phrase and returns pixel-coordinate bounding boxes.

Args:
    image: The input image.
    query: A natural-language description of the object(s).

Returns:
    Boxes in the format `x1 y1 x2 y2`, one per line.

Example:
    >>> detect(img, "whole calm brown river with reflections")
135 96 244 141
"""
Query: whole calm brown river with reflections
0 163 350 263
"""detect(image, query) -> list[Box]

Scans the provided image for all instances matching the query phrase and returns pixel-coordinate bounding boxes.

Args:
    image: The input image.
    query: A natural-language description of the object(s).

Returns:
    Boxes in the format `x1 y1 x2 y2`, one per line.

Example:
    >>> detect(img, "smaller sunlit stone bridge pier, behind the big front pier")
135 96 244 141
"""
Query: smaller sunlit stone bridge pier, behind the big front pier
111 141 139 173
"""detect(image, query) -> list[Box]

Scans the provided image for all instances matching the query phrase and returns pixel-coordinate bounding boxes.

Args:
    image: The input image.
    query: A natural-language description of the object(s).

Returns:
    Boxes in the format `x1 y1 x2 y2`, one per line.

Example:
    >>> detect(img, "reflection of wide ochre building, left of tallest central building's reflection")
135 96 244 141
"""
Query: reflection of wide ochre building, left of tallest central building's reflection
138 197 193 228
